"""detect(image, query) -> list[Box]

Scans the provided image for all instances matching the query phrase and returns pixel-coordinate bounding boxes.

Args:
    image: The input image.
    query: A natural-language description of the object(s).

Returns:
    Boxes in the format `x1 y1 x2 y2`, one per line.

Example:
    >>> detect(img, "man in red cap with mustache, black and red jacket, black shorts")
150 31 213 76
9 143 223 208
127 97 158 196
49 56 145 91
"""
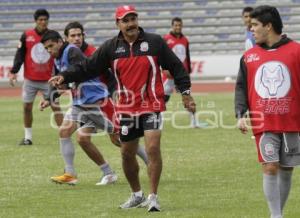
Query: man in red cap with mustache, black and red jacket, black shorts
49 6 195 212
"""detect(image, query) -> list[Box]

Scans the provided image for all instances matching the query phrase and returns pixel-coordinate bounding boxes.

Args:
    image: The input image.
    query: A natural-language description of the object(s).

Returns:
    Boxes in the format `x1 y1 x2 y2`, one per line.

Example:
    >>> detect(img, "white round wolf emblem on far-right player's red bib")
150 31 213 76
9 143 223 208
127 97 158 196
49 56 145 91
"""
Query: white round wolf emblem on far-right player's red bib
255 61 291 98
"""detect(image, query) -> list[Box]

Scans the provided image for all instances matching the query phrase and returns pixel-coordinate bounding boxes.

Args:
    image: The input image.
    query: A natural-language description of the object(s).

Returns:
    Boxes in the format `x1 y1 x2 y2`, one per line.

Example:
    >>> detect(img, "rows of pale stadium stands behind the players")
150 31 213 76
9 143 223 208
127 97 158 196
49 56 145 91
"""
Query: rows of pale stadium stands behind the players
0 0 300 59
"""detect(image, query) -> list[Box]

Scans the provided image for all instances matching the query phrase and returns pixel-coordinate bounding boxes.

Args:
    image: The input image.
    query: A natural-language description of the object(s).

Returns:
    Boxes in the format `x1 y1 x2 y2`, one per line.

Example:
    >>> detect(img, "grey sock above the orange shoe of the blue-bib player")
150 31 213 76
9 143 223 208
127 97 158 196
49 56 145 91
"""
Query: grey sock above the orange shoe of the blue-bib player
59 138 76 175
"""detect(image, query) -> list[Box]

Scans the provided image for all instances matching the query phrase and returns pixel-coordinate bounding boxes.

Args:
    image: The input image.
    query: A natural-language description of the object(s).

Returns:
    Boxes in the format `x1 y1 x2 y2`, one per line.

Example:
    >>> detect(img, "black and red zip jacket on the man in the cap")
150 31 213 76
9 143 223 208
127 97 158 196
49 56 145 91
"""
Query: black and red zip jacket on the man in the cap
62 28 191 115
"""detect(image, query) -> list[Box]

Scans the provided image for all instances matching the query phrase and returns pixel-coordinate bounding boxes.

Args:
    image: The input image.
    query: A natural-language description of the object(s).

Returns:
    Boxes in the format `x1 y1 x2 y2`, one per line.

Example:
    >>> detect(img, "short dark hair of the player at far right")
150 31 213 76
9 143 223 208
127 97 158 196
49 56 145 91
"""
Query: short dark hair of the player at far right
250 5 283 34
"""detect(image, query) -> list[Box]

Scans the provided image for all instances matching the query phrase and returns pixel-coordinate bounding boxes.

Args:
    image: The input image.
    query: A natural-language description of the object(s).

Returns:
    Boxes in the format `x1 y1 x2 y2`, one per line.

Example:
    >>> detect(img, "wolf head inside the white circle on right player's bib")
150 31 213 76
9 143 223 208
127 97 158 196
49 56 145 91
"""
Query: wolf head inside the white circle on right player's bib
261 65 284 96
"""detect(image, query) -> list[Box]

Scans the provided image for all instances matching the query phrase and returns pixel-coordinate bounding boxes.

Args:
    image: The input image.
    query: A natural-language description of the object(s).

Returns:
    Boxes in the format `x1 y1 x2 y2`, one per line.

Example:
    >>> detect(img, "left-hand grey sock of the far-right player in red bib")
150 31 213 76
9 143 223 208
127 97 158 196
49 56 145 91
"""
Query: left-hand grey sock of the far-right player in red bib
263 174 281 217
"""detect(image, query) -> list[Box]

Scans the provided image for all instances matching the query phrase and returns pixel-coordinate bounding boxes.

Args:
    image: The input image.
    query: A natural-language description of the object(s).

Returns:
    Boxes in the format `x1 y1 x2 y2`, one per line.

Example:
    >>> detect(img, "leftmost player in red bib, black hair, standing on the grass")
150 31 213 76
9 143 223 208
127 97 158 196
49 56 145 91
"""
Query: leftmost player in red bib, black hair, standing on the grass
9 9 63 145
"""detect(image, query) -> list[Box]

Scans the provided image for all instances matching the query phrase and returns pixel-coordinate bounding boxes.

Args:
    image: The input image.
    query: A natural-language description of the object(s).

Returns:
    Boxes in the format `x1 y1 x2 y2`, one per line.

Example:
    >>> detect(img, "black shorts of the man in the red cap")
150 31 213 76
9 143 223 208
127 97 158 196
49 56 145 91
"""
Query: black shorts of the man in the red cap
120 112 162 142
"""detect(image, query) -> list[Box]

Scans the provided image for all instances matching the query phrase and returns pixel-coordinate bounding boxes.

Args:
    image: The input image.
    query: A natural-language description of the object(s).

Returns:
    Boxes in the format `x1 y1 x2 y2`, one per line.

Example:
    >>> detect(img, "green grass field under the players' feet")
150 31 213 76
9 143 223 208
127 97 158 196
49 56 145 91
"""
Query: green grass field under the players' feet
0 93 300 218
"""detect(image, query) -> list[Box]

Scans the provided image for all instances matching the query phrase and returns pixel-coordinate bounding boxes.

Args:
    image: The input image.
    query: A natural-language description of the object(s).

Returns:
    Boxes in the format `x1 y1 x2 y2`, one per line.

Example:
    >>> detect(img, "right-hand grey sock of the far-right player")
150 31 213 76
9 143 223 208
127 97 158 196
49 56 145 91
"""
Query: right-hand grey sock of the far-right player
278 170 293 211
